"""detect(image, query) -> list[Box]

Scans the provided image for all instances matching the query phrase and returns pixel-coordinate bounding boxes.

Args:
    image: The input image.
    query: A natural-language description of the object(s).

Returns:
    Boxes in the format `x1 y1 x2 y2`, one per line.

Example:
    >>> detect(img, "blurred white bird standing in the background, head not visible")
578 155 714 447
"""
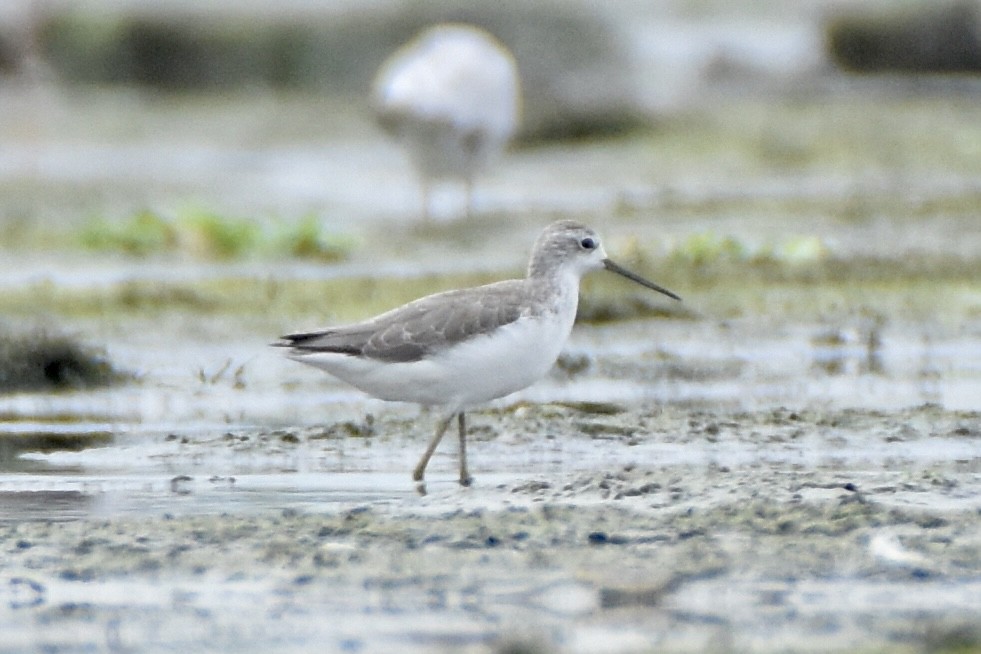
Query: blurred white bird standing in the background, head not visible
374 24 521 221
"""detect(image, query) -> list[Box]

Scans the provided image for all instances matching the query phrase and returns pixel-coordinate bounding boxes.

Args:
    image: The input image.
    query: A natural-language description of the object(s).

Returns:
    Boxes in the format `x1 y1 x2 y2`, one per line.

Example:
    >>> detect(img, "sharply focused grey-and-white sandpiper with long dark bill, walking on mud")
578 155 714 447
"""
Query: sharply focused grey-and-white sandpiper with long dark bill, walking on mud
274 220 681 490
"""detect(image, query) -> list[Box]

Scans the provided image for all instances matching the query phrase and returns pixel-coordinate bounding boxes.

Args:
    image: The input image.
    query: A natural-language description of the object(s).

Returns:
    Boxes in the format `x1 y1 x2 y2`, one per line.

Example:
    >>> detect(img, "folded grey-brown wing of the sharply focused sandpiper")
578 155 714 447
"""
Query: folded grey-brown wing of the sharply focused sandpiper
282 281 524 362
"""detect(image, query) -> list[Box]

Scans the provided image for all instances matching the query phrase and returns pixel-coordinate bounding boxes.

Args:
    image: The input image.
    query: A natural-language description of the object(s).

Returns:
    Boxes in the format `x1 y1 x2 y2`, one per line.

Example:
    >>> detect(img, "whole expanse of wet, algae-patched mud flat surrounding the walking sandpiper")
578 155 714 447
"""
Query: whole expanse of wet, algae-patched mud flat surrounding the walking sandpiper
0 5 981 653
